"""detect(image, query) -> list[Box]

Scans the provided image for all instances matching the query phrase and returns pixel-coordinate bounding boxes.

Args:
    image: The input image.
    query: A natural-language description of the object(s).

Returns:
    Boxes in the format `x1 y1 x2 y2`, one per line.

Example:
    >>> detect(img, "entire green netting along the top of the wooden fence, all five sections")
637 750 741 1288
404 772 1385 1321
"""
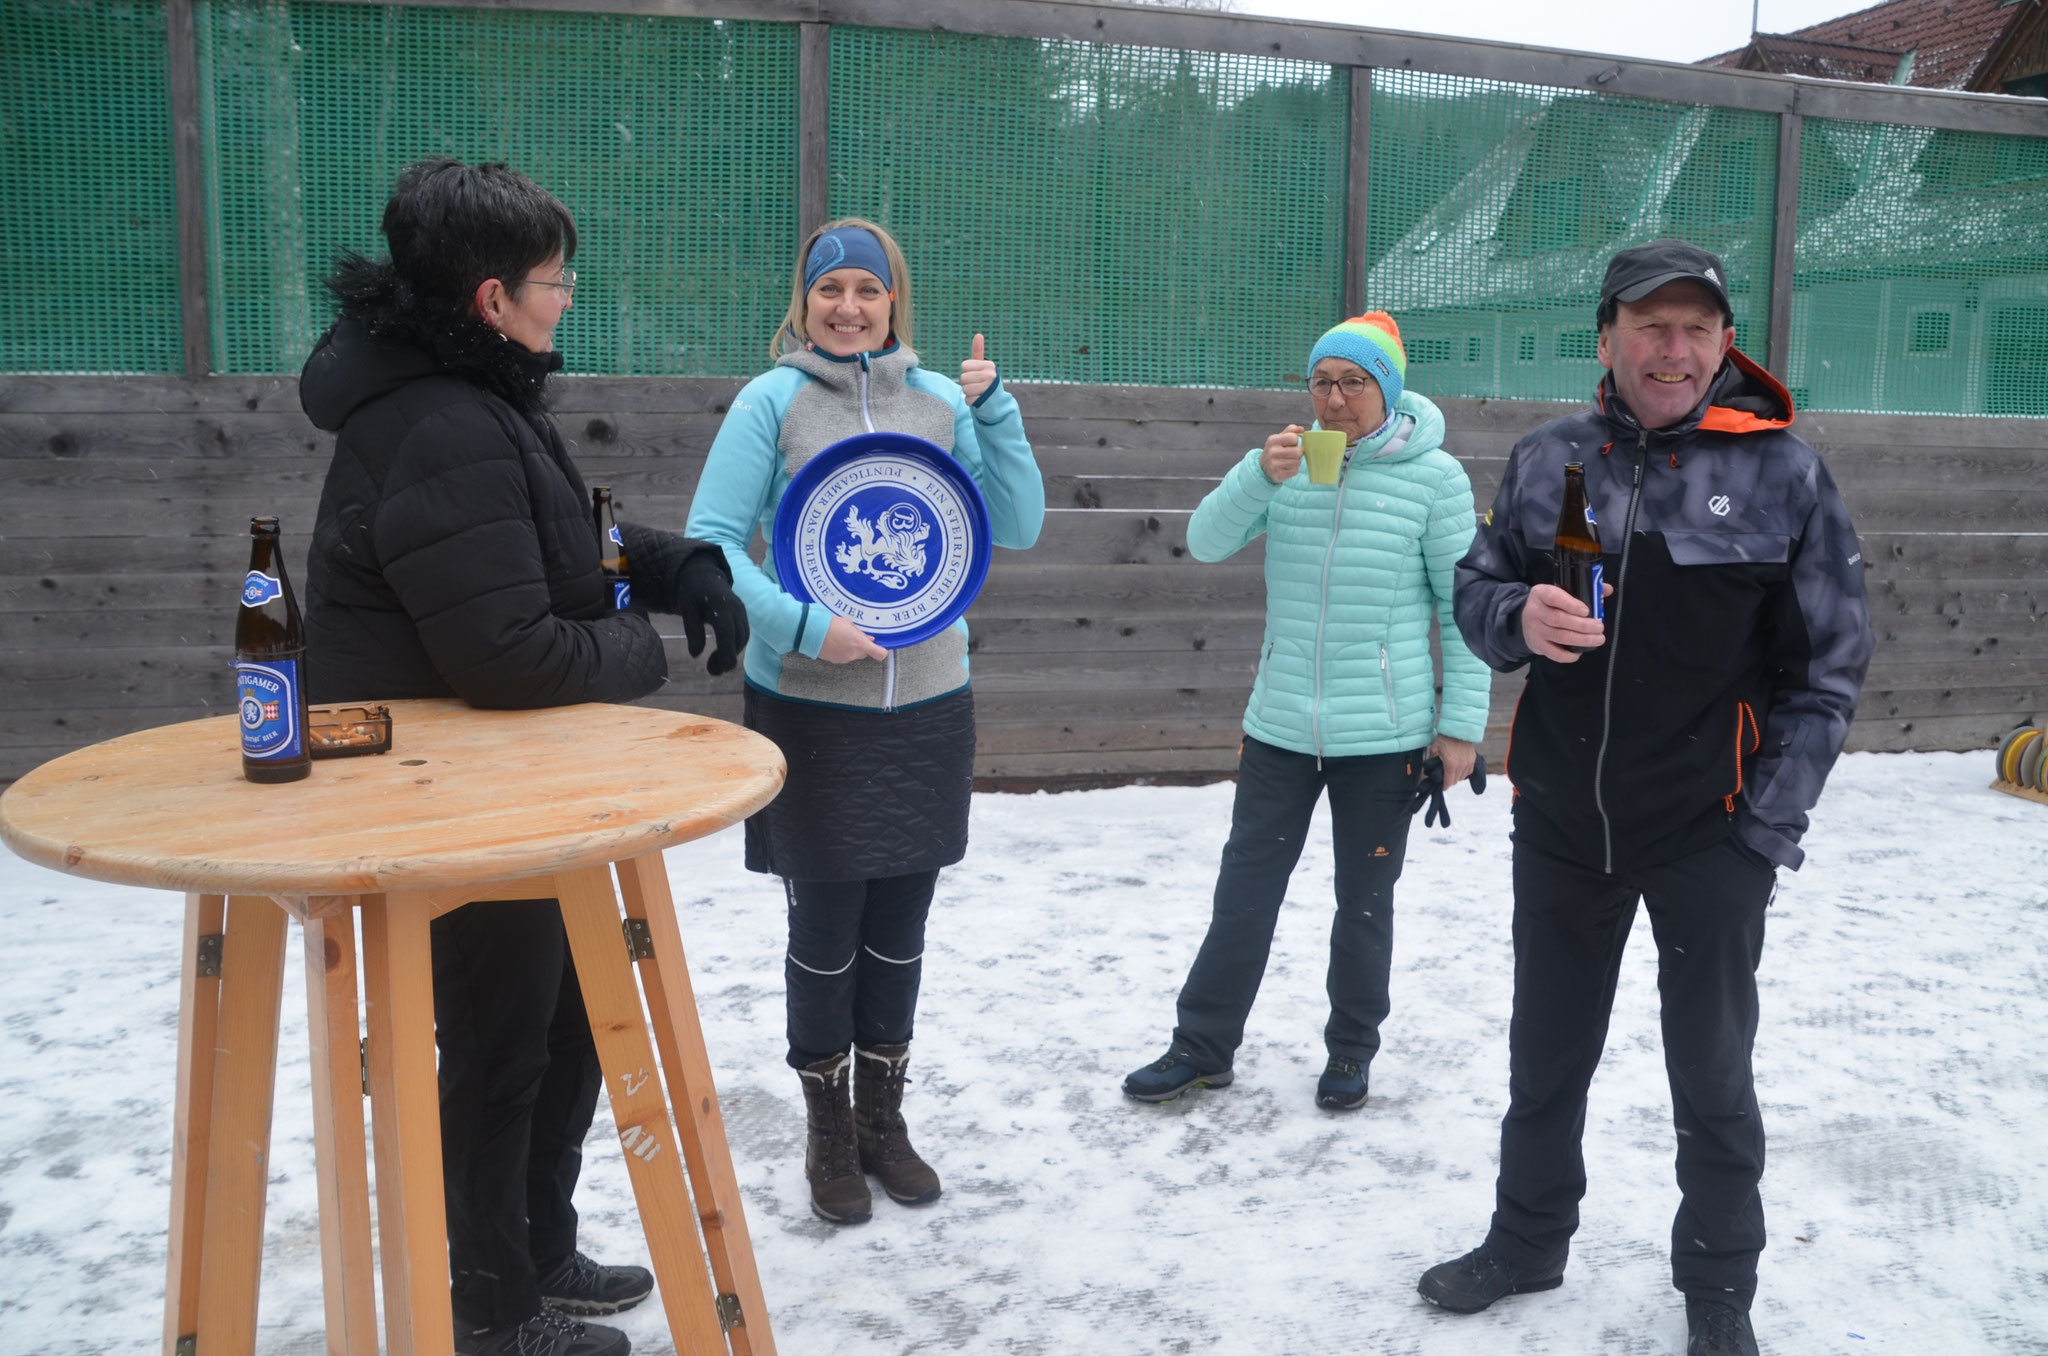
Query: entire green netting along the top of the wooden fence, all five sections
0 0 2048 416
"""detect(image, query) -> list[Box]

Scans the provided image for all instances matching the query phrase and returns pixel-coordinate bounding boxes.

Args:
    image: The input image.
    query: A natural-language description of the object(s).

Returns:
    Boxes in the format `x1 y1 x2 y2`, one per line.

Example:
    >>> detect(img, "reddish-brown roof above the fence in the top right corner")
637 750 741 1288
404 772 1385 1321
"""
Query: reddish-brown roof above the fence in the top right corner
1700 0 2044 90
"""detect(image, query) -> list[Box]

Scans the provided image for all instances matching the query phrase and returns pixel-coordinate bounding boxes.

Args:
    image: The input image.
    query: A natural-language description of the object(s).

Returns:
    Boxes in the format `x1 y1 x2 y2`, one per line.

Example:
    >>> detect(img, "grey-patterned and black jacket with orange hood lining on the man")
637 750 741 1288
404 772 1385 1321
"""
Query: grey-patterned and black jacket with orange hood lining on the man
1456 350 1872 873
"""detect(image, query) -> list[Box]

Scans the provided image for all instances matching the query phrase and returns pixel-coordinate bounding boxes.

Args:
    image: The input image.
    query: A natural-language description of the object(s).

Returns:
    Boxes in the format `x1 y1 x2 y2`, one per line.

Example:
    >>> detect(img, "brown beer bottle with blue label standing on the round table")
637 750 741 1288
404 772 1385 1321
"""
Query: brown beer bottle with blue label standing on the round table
236 518 313 782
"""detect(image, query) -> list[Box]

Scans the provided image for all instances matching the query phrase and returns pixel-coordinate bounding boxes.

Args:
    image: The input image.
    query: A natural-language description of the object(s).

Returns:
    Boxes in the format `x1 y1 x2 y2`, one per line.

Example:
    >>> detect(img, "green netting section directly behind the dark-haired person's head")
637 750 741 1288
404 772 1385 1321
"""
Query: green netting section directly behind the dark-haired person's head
197 0 797 375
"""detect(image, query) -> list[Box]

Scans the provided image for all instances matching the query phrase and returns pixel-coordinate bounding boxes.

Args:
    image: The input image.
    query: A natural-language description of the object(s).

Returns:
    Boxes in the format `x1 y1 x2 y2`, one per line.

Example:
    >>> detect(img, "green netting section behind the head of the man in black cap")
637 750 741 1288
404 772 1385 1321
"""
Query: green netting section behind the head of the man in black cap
1366 70 1778 399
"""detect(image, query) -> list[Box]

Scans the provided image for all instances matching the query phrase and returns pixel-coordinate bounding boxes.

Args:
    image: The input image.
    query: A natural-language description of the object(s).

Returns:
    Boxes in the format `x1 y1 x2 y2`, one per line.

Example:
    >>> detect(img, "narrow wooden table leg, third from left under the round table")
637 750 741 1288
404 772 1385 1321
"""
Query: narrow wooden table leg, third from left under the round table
305 909 377 1356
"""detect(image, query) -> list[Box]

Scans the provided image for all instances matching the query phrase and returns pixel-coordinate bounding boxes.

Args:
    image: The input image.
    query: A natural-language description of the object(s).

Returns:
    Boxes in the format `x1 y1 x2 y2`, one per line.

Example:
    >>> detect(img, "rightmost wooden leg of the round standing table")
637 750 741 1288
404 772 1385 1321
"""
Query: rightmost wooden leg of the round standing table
618 852 774 1356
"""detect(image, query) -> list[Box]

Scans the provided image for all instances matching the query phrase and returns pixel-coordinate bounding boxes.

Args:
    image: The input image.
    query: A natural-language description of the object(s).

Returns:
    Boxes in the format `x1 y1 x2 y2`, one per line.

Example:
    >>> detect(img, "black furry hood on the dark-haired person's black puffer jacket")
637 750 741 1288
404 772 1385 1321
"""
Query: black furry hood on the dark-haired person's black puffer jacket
299 254 561 432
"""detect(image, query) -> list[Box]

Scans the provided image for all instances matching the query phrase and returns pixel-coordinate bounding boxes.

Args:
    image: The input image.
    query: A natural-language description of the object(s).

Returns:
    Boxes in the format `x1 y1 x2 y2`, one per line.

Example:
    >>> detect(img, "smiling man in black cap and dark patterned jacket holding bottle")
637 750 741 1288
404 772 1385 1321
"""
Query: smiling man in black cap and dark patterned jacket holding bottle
1421 240 1872 1356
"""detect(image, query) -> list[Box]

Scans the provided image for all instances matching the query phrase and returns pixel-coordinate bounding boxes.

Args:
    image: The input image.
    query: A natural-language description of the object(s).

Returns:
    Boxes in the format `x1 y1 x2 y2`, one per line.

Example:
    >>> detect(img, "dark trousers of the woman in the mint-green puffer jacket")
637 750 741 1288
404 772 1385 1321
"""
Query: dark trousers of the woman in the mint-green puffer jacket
1174 737 1421 1069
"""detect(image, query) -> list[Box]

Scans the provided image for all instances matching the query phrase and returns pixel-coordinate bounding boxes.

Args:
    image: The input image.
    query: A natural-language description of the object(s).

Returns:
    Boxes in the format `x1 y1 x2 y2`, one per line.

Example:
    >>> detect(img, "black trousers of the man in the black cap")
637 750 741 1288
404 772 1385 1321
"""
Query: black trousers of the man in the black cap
1487 838 1776 1309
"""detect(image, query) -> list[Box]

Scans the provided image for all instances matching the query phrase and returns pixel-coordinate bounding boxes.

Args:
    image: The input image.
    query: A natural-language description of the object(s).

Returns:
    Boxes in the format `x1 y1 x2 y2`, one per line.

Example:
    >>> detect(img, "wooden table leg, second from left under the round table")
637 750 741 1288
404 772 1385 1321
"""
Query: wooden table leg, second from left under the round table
195 895 287 1356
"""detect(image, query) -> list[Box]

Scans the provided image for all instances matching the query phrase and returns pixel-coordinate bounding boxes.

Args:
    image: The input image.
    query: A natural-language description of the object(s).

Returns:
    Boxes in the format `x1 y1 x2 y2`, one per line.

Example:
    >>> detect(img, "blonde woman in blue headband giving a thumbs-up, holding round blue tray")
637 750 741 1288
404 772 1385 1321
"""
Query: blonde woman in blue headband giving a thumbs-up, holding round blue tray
690 217 1044 1225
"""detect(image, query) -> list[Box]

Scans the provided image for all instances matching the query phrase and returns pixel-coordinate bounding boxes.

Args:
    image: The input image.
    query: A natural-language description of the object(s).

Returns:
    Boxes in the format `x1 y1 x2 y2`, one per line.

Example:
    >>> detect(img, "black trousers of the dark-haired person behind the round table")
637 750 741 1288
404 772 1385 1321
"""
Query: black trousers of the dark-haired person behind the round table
432 899 604 1327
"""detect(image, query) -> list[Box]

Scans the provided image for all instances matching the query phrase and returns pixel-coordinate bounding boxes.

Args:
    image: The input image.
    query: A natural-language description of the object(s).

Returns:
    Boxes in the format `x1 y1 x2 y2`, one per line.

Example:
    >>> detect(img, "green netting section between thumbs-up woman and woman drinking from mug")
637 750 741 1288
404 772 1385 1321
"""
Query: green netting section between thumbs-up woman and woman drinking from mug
829 27 1350 387
